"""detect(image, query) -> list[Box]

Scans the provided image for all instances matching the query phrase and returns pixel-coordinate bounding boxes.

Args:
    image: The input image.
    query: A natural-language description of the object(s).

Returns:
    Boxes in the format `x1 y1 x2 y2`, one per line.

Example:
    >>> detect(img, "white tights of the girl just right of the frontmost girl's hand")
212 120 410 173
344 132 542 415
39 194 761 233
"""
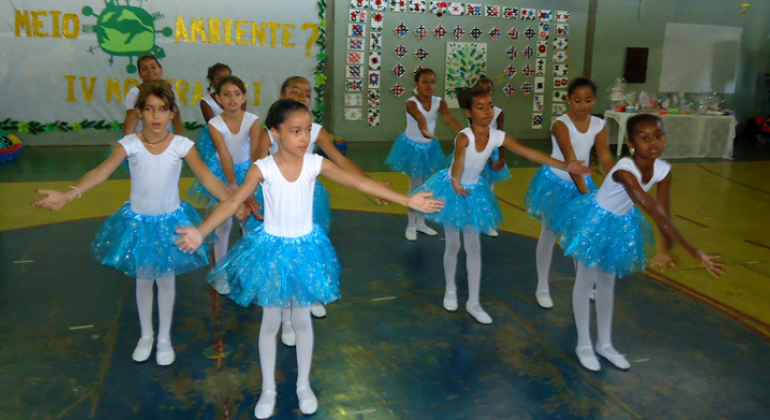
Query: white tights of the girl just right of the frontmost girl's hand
444 227 481 304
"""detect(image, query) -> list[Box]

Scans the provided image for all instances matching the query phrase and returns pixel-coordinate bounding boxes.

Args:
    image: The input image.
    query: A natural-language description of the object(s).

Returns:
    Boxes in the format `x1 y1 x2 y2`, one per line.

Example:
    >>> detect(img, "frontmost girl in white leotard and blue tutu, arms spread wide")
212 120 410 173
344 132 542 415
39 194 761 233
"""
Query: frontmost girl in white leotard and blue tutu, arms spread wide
172 99 442 419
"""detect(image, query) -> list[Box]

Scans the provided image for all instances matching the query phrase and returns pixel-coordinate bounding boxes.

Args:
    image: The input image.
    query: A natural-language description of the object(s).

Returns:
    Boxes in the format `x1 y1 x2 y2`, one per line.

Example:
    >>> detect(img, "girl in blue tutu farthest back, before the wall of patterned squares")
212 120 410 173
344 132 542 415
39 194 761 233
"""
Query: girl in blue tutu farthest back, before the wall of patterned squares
385 69 462 241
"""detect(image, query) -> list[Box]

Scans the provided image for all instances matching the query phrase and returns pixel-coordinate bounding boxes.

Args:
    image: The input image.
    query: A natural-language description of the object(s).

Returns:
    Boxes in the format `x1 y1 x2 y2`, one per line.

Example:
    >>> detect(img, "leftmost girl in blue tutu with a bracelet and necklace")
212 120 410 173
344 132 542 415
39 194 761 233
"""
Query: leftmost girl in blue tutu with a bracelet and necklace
34 80 234 365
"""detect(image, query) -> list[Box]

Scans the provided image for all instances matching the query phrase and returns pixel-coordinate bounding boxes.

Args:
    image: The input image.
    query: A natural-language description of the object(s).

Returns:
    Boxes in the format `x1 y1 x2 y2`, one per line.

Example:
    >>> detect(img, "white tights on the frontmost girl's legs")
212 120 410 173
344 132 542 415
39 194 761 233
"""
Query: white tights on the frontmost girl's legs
259 308 313 392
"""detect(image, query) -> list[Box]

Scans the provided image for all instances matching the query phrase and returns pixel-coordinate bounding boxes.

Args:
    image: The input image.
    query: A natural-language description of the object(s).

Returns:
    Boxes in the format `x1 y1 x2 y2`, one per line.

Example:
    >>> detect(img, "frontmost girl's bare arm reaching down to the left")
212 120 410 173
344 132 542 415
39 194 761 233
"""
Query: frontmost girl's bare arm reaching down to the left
175 162 263 253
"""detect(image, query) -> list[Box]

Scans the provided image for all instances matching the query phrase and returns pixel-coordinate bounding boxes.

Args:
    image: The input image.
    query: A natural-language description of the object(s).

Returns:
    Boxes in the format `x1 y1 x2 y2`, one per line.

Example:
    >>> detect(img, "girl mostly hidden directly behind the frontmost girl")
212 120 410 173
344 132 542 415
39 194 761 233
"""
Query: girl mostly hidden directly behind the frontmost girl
244 76 390 346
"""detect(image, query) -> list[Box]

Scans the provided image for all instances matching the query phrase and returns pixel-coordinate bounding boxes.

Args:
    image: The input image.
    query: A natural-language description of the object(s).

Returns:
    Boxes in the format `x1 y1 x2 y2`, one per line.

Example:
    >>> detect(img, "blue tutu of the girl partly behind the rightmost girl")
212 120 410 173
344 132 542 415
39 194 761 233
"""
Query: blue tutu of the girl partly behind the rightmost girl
524 165 597 230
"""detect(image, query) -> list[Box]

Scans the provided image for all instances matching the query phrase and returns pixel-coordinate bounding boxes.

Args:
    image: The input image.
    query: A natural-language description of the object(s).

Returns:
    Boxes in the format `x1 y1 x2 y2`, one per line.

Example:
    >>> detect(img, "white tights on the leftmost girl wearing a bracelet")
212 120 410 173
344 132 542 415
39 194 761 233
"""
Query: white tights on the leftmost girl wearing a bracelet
136 274 176 341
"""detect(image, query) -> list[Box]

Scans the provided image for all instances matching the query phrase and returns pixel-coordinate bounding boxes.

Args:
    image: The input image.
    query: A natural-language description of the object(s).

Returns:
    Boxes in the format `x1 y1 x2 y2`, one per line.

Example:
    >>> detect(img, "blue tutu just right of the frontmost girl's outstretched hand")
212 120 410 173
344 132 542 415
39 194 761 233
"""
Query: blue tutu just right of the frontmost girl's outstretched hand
412 169 503 233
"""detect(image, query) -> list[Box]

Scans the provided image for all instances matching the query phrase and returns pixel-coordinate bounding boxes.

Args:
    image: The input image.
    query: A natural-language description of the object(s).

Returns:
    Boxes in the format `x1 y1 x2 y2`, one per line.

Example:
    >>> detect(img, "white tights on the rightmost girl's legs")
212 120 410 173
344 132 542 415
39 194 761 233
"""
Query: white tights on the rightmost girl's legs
572 261 615 349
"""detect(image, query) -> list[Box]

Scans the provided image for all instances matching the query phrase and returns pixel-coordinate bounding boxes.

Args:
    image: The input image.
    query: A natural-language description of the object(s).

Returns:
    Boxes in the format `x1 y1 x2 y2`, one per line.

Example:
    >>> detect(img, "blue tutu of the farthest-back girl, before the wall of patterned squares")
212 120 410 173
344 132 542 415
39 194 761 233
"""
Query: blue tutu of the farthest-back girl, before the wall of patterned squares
385 133 444 179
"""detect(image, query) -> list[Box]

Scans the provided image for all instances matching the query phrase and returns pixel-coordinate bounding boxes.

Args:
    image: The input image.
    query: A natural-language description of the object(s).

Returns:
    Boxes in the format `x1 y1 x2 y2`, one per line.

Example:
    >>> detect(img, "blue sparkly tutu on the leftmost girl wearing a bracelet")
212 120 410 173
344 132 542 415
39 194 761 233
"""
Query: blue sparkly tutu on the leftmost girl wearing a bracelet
91 201 216 279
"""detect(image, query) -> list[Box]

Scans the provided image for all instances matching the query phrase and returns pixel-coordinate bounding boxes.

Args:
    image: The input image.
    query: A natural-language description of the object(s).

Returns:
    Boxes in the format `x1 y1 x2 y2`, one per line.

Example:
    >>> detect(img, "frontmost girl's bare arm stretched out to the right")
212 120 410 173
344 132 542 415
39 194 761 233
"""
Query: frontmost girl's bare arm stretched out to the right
321 159 444 213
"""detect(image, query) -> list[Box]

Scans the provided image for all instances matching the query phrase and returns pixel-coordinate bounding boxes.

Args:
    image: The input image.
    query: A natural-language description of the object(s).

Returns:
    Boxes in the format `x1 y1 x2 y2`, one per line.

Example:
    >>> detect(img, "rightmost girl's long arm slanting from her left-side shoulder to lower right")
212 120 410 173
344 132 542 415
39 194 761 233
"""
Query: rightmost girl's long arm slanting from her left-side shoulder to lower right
612 170 724 277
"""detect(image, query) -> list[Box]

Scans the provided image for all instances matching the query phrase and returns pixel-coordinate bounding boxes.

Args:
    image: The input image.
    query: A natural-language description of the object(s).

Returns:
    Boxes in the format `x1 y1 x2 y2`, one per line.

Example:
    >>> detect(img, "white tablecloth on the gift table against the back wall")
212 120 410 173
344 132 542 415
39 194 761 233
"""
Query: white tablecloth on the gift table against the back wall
604 111 738 159
